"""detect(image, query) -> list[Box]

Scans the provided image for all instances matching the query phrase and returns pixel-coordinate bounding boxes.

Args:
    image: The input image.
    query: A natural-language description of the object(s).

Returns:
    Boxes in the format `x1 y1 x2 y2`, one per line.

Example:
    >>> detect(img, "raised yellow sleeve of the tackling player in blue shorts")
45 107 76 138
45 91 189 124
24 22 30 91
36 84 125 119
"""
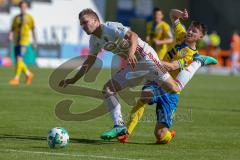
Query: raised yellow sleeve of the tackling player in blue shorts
173 20 187 43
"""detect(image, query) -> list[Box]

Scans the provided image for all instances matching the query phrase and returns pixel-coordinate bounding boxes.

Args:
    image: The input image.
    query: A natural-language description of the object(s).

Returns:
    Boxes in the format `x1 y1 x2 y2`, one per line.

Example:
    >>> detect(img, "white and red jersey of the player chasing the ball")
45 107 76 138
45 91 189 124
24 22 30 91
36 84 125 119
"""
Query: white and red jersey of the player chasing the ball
89 22 158 60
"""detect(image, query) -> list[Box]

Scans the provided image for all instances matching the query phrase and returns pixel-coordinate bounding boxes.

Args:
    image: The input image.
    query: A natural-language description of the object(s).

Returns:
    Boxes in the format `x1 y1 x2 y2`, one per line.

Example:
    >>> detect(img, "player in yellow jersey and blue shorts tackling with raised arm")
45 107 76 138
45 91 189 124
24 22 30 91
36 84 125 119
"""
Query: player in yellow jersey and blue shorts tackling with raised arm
118 9 218 144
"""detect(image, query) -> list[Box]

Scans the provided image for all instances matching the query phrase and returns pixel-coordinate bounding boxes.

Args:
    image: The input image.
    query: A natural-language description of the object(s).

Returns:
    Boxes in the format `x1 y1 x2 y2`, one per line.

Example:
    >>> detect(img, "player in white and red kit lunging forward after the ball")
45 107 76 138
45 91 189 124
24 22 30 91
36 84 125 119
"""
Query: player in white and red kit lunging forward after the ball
59 9 217 139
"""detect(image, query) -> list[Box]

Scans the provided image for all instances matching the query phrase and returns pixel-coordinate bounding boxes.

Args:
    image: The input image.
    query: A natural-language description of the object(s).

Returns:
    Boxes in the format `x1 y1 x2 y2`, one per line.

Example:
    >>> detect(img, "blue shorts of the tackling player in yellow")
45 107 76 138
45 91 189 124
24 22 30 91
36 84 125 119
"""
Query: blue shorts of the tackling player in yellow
143 82 179 128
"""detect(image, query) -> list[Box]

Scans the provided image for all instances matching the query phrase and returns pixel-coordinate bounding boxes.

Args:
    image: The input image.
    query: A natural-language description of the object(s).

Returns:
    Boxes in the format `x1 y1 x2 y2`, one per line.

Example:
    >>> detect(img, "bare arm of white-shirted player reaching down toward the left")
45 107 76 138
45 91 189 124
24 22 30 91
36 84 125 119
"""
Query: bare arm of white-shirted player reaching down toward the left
59 55 97 88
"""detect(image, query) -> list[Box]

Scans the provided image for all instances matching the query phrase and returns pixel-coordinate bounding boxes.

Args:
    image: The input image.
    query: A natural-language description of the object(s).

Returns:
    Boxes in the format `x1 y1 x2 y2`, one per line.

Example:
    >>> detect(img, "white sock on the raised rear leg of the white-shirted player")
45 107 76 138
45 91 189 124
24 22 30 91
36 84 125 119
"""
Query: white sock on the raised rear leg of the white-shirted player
176 61 201 90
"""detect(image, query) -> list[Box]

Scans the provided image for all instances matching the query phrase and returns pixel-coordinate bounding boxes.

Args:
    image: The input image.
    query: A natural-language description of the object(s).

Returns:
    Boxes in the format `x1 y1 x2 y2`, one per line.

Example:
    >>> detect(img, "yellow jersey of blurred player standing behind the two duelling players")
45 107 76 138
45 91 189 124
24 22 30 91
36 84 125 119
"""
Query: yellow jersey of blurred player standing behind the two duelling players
146 21 172 60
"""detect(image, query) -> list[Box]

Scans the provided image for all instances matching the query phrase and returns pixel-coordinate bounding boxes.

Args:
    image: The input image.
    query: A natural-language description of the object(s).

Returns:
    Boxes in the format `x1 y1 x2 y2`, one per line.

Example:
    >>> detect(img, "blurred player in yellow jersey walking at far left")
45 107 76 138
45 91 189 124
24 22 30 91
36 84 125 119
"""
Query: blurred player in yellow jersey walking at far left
9 1 36 85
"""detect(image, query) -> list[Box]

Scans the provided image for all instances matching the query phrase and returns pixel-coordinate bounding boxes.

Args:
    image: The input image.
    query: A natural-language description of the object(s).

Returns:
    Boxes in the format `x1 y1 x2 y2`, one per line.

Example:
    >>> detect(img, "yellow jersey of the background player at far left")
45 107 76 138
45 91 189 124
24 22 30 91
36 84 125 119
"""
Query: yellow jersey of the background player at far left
12 14 35 46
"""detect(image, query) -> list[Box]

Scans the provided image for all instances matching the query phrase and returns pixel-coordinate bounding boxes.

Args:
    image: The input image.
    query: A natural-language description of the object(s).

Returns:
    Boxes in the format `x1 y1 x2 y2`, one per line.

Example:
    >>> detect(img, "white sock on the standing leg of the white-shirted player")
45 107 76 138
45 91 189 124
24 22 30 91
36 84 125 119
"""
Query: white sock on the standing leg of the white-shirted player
106 95 124 126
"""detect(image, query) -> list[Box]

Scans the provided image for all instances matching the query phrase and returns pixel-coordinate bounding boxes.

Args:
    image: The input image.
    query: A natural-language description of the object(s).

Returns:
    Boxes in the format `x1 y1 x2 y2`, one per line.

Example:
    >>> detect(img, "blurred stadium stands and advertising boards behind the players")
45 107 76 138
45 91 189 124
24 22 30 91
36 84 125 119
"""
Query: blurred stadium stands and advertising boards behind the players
0 0 240 68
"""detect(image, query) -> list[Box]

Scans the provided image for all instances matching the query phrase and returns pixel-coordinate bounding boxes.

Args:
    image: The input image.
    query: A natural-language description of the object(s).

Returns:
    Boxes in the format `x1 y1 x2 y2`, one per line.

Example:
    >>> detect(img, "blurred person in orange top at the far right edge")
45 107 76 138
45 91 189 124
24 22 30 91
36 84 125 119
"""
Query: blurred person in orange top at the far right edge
231 31 240 74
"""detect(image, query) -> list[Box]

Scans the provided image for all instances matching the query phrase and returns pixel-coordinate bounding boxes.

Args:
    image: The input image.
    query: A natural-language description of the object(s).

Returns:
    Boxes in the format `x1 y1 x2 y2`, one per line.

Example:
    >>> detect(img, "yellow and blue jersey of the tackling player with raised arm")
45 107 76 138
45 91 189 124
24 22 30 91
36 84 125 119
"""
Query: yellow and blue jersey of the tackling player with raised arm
163 21 198 79
